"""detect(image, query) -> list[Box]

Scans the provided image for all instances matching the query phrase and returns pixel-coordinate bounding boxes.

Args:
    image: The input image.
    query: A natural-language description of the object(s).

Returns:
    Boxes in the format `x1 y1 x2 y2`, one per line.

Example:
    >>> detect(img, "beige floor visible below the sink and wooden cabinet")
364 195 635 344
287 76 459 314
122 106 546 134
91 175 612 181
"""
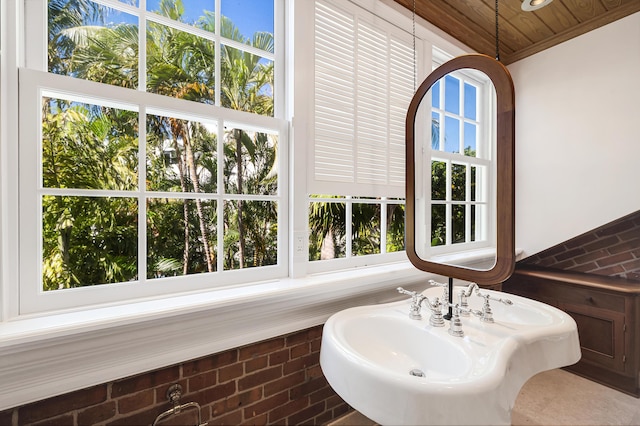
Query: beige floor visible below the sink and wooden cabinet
330 370 640 426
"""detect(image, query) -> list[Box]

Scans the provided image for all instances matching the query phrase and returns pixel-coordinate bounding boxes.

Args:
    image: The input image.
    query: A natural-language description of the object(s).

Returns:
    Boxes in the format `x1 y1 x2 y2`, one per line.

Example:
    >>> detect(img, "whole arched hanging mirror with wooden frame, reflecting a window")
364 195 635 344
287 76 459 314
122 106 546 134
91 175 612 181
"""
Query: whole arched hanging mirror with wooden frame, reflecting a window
406 55 515 284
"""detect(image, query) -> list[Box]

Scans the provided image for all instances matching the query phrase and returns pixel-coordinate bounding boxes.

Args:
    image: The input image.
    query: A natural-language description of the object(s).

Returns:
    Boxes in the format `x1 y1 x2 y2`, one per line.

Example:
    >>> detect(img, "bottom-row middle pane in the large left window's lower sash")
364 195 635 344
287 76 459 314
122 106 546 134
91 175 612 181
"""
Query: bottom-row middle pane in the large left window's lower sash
147 198 217 279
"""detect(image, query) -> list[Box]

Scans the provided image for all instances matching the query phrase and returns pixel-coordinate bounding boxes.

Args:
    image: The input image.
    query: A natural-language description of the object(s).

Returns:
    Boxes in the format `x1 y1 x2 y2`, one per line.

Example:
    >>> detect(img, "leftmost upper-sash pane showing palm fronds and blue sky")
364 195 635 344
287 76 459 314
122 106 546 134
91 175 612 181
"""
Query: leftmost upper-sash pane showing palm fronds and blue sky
48 1 138 88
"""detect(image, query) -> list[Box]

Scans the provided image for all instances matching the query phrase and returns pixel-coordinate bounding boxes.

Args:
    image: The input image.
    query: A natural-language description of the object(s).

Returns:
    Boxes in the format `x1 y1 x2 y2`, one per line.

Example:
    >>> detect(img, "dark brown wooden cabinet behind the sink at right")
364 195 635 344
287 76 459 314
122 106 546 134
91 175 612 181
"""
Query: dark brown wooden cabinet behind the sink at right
502 266 640 397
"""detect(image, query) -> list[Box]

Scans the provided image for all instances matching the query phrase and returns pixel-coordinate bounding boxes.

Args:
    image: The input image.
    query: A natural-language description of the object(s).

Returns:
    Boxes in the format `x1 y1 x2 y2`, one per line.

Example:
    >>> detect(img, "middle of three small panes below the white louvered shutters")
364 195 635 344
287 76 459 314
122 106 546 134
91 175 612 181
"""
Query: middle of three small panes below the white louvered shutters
351 203 381 256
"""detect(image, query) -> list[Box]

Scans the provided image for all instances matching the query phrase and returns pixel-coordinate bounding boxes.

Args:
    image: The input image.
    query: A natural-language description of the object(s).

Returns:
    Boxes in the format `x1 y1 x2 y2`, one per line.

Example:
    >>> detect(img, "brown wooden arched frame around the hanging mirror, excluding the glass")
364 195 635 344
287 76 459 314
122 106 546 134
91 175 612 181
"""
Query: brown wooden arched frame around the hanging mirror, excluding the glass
405 54 515 284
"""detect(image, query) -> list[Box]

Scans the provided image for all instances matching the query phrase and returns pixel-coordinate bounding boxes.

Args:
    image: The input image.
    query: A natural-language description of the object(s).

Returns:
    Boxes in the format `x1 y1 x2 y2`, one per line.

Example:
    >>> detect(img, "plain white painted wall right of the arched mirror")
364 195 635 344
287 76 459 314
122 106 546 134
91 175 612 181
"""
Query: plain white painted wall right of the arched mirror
509 13 640 256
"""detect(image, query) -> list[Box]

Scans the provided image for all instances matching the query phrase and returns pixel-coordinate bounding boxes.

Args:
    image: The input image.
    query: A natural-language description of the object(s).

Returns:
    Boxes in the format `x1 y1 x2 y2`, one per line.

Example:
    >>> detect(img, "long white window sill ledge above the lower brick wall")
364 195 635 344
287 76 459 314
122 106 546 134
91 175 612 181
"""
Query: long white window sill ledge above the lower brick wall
0 261 433 410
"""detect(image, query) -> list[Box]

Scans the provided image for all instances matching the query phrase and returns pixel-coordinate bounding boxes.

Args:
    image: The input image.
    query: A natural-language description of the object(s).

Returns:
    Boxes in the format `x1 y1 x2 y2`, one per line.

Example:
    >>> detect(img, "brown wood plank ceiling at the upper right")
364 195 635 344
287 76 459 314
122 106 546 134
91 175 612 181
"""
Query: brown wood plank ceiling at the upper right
395 0 640 64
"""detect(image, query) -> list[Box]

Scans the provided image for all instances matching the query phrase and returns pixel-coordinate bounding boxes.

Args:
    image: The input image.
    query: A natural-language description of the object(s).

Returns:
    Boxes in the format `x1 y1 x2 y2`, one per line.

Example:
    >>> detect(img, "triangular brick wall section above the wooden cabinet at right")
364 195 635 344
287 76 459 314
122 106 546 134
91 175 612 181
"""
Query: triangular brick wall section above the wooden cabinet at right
518 211 640 281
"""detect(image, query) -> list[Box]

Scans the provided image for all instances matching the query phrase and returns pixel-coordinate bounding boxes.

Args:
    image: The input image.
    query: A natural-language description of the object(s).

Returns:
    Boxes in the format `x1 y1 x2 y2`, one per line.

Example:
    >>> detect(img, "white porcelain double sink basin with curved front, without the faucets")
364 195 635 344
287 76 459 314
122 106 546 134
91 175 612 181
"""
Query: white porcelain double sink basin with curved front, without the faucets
320 288 580 425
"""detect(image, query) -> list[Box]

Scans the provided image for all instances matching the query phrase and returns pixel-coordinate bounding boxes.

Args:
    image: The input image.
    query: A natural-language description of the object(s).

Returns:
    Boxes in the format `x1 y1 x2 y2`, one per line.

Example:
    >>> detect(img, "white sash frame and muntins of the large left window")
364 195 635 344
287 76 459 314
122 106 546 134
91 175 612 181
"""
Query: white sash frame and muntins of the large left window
19 0 289 315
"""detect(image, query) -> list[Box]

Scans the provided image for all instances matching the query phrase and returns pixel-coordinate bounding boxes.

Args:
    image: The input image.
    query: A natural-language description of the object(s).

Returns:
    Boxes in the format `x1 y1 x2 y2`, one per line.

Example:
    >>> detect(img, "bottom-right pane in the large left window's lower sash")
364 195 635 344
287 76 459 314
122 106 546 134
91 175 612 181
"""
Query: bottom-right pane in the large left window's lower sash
224 200 278 270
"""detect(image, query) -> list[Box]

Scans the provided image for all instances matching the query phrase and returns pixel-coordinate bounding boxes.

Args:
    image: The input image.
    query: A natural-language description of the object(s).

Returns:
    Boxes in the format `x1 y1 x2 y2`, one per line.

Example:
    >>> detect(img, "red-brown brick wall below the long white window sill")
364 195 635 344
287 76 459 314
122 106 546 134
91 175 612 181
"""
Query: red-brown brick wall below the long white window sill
0 326 350 426
